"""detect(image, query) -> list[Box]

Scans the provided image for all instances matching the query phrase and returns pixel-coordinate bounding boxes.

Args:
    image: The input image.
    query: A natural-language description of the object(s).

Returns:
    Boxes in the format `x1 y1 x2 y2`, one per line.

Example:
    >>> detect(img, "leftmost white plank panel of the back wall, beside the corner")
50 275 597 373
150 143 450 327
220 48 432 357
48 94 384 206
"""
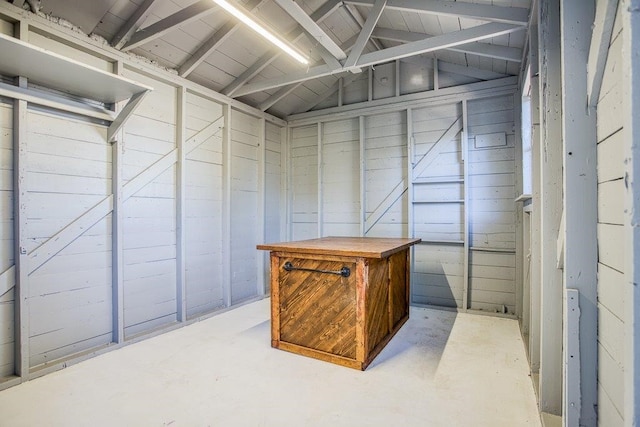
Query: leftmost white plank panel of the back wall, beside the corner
289 124 318 240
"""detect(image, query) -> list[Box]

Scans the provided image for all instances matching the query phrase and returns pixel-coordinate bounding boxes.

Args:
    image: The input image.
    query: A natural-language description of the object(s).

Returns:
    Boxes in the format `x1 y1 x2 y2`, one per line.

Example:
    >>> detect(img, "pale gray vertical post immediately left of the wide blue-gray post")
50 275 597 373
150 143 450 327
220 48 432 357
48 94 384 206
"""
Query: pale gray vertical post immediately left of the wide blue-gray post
534 0 564 415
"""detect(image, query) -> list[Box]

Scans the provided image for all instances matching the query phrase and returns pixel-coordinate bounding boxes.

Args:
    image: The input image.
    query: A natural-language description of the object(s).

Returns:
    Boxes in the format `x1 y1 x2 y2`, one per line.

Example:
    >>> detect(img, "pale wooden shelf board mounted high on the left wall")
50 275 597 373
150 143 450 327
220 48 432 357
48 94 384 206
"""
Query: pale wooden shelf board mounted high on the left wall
0 34 151 103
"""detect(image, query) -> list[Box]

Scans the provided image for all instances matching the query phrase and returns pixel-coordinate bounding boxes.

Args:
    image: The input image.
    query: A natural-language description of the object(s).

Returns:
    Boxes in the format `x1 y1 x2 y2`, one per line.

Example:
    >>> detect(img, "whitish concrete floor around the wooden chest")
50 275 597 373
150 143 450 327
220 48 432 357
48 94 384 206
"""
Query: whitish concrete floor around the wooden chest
0 299 540 427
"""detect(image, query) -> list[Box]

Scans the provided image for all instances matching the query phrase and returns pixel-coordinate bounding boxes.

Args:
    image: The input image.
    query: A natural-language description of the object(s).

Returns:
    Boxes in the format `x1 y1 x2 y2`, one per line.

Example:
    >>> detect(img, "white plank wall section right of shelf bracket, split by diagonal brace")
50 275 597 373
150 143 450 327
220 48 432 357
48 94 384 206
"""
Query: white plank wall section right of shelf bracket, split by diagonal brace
123 70 177 337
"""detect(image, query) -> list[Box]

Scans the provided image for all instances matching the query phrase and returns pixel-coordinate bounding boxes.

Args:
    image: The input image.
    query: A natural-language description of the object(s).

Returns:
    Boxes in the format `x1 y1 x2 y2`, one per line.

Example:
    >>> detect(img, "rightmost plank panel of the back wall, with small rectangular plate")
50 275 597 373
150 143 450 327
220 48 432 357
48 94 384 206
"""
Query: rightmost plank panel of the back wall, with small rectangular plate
467 96 517 314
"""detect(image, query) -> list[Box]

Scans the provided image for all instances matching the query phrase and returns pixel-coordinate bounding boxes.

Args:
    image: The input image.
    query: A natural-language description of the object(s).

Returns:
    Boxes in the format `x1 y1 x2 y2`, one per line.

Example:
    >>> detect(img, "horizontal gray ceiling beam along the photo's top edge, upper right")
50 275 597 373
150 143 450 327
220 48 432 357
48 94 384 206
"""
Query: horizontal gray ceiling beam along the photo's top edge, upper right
345 0 529 25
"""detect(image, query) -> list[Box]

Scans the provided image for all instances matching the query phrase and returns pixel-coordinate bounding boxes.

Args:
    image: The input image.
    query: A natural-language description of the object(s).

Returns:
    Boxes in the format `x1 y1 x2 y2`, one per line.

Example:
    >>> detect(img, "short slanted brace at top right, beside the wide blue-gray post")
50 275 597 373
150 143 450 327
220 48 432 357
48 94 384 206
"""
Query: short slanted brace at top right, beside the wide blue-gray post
587 0 619 107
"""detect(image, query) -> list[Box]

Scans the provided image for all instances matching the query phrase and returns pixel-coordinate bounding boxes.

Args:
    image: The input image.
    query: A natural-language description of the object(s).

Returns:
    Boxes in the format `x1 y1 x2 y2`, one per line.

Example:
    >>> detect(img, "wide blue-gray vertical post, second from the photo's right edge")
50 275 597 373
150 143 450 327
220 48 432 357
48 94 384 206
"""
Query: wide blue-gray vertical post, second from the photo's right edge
560 0 600 426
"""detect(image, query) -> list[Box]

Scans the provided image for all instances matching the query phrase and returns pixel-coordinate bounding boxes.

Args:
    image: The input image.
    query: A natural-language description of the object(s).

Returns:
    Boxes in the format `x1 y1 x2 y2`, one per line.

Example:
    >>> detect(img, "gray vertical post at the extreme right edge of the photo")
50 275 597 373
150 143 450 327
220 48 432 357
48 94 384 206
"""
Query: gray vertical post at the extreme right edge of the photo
621 0 640 424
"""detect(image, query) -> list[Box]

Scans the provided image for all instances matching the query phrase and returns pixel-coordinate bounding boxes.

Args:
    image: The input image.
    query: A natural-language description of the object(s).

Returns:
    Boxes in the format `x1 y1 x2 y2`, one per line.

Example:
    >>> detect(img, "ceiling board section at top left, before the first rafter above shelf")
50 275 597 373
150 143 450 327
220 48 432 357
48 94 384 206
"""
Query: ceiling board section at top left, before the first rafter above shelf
41 0 116 34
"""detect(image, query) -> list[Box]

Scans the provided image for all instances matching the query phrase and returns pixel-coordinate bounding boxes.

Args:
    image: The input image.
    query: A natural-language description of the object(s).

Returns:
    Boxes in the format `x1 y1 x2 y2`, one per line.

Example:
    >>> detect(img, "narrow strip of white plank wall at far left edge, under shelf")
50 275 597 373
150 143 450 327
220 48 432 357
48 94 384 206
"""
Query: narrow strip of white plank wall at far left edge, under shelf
0 99 15 378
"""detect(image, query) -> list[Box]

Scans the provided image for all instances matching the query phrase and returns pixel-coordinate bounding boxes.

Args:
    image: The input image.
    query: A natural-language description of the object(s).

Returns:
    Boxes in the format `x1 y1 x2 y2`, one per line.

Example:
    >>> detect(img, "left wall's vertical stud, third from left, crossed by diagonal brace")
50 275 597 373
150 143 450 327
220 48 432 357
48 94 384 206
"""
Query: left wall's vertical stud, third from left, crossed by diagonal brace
176 86 187 322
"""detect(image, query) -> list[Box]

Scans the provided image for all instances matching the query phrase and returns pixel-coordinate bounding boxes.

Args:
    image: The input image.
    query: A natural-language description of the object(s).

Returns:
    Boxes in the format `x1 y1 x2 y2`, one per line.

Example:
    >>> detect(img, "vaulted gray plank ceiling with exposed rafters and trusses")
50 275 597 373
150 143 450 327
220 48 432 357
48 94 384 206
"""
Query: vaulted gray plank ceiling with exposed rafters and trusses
12 0 530 117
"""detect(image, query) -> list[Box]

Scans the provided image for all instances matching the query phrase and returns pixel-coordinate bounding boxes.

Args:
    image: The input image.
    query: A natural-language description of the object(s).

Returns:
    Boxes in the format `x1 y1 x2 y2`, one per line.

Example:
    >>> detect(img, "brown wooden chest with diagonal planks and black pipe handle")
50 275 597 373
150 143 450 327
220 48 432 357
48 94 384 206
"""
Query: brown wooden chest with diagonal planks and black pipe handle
258 237 420 370
